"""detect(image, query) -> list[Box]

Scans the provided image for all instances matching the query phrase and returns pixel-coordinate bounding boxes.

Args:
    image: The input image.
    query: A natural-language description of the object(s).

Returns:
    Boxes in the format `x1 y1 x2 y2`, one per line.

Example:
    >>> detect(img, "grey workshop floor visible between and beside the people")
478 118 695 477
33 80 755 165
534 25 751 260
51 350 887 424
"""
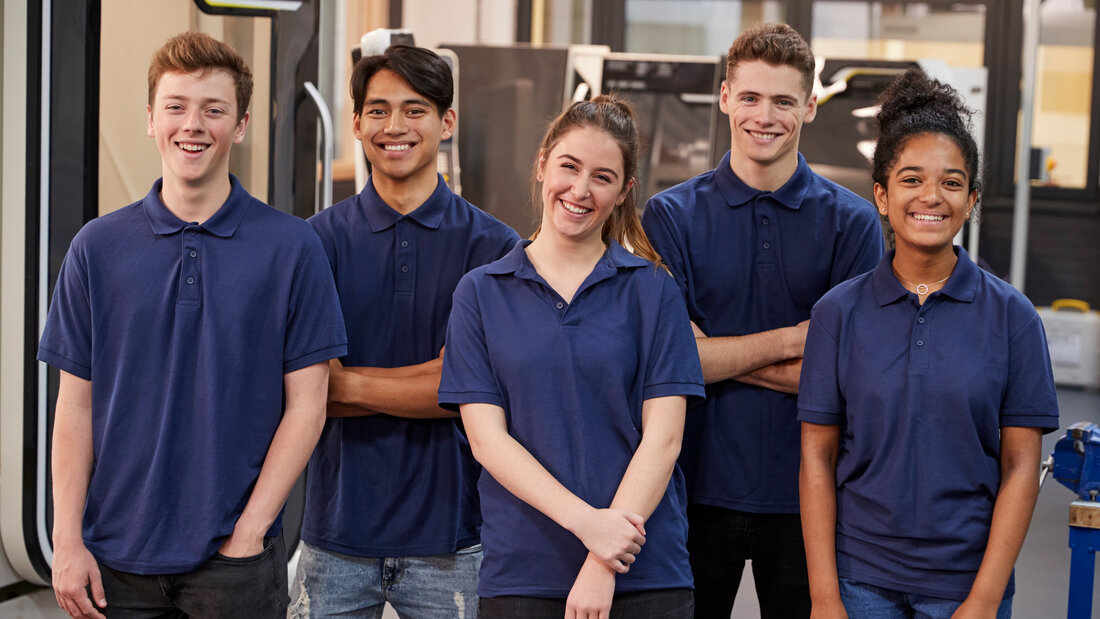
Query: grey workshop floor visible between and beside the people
0 389 1100 619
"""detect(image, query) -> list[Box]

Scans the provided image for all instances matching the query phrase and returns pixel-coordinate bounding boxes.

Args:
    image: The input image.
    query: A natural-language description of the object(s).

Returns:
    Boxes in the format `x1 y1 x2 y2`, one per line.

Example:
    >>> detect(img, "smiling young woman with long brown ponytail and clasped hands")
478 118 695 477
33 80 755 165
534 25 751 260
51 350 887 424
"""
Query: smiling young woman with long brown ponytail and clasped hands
439 96 704 618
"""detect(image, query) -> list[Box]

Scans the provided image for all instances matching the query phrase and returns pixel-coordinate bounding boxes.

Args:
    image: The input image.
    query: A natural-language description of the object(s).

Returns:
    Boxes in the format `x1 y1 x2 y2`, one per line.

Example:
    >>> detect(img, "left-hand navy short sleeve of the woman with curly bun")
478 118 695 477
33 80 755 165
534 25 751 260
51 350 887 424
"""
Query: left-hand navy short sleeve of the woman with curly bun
799 302 846 425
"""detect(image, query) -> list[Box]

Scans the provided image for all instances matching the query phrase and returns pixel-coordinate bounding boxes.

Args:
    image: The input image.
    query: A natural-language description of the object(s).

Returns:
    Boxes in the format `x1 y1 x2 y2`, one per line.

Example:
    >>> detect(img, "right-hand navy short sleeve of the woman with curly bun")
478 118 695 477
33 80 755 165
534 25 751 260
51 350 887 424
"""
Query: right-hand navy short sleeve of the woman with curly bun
1001 314 1058 433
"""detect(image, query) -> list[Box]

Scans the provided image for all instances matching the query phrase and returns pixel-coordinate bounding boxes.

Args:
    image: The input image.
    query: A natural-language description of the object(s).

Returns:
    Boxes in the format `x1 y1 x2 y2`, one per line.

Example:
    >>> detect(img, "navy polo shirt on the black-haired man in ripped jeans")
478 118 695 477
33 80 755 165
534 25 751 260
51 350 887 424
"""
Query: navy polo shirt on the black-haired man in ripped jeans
301 177 519 556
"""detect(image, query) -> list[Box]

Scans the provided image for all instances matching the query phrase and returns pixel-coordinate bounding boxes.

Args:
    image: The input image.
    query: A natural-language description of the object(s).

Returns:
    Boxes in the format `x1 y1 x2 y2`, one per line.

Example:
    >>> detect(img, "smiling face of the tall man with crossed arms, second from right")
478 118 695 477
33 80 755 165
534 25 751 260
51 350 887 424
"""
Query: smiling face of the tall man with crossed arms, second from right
718 60 817 189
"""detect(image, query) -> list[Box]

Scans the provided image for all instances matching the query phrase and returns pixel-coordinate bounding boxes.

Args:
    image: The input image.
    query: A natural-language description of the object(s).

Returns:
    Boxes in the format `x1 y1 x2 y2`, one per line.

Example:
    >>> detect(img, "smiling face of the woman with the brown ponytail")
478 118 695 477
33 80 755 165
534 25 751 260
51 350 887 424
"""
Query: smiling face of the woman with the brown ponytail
537 126 633 247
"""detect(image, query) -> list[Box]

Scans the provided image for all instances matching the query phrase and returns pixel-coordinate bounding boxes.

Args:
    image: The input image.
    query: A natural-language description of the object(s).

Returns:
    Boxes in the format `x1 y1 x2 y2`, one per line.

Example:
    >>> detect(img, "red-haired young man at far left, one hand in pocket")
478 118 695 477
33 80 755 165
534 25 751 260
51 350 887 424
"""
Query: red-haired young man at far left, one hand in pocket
39 32 347 619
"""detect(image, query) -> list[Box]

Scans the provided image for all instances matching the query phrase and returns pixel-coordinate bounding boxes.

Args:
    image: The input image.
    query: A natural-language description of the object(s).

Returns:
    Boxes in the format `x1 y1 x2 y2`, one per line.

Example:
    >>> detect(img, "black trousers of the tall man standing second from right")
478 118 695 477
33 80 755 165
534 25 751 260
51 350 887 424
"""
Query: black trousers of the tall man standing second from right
688 505 810 619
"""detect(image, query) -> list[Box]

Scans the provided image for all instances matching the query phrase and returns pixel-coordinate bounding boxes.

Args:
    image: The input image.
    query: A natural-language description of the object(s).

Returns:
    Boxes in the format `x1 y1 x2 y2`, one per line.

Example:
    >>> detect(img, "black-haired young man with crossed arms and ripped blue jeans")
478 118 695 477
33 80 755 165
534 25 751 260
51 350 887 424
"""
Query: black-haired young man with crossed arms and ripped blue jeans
290 45 518 618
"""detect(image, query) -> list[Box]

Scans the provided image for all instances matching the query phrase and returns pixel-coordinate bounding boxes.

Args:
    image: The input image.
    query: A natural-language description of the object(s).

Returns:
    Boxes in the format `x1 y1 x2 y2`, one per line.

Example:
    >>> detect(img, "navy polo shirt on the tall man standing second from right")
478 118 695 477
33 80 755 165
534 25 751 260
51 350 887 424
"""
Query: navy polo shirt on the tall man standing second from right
642 153 882 513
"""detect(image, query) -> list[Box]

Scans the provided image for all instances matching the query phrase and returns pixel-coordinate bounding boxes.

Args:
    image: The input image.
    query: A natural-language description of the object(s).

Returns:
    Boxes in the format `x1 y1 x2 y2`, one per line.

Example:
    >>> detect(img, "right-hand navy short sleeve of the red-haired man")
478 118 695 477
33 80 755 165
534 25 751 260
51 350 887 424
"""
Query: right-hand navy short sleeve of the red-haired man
283 229 348 374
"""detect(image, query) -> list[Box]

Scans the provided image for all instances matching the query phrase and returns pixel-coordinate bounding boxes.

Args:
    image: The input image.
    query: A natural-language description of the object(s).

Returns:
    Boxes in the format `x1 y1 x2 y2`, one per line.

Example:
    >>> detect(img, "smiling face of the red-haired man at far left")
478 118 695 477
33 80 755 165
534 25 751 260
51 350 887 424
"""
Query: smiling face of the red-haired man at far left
147 69 249 187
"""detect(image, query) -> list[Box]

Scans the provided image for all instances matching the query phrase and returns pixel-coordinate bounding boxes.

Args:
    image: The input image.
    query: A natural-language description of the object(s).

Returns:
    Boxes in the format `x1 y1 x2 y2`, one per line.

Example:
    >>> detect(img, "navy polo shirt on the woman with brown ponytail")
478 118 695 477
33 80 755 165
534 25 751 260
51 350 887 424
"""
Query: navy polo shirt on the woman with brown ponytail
439 242 704 598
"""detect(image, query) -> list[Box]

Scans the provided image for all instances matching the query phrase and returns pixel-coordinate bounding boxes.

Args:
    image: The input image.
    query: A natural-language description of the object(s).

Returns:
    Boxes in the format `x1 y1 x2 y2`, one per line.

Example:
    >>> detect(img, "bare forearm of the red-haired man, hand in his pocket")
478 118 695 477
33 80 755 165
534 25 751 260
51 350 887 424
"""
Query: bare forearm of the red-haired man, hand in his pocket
234 363 328 539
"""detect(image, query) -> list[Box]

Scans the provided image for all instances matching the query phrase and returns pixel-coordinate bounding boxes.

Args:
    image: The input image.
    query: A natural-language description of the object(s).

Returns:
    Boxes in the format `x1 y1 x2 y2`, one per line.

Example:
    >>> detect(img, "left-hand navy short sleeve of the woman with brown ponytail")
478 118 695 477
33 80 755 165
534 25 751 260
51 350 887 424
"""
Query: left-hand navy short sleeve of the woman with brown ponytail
439 269 504 411
